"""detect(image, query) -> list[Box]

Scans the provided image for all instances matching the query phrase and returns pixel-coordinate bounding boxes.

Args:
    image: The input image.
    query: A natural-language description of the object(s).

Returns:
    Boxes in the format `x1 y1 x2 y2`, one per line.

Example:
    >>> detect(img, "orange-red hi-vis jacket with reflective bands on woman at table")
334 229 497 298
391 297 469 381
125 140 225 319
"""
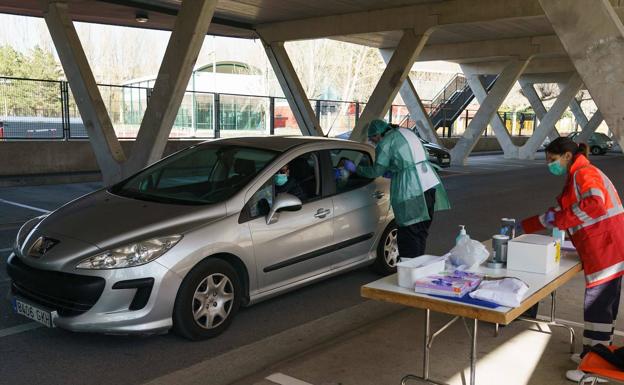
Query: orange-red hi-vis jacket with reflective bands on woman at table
522 155 624 287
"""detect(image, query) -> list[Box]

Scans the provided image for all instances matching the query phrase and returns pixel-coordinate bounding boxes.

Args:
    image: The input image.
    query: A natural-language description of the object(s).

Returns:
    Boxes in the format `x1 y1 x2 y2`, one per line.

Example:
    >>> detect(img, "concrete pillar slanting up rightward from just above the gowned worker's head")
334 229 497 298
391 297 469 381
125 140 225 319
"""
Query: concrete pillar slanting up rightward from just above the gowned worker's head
351 29 429 142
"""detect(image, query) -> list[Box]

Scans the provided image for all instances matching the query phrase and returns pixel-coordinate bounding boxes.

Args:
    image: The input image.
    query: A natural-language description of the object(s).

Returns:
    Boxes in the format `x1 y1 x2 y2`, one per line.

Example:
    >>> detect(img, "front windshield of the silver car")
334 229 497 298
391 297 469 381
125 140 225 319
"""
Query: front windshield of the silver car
109 144 279 205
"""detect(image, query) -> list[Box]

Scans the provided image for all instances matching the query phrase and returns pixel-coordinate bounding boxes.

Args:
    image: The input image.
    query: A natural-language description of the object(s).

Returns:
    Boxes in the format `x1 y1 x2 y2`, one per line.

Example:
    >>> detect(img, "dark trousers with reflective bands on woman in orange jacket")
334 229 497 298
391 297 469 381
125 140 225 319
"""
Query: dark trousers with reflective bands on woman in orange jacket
583 277 622 353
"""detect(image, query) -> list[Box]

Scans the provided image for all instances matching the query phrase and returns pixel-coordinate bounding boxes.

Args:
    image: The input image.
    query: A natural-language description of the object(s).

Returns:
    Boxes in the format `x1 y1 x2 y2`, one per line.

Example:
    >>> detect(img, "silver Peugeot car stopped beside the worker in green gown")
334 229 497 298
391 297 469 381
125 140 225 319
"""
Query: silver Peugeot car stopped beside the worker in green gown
7 137 397 340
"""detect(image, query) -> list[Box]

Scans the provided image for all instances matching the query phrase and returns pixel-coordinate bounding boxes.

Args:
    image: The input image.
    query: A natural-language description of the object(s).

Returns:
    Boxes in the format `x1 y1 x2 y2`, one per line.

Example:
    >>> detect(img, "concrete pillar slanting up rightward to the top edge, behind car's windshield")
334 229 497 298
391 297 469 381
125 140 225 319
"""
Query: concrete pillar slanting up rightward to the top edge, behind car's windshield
123 0 217 175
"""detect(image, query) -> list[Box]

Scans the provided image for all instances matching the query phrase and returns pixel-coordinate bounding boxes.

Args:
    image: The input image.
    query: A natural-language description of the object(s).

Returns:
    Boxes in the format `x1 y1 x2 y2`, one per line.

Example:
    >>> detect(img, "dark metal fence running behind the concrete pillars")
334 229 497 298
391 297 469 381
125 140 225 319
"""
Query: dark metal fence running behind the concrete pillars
0 77 424 140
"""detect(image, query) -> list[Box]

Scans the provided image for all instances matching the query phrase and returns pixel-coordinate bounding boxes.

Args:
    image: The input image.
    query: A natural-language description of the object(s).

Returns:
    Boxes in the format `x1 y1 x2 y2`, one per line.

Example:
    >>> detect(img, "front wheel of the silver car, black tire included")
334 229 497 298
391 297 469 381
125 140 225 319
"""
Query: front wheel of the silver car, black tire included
173 258 242 341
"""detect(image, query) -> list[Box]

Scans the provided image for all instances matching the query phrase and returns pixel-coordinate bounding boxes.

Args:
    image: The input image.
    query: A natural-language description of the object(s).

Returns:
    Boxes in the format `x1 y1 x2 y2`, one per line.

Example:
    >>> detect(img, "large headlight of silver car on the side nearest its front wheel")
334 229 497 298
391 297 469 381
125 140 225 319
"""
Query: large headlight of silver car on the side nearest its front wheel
76 235 182 270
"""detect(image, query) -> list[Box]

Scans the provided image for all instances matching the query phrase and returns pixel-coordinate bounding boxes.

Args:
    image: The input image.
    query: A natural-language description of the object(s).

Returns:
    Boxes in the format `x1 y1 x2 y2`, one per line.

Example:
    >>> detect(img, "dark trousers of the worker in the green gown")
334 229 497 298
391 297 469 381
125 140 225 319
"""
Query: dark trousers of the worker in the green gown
397 188 436 258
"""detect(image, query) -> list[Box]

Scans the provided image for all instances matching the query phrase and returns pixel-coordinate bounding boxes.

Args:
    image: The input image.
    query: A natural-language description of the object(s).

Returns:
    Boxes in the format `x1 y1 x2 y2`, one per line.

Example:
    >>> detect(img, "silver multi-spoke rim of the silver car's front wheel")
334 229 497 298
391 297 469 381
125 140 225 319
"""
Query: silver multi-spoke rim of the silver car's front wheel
191 273 234 329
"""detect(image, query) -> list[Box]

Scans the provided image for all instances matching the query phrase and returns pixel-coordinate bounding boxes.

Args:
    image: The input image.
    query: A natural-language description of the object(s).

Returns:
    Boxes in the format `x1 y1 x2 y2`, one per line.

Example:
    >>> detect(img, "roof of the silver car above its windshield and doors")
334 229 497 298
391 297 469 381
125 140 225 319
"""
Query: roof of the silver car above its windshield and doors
195 136 355 152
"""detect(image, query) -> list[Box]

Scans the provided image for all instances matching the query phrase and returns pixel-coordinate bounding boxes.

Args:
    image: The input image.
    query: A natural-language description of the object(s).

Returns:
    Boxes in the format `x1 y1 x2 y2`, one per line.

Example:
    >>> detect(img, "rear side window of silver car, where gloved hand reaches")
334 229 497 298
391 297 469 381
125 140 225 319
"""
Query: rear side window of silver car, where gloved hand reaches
329 149 373 193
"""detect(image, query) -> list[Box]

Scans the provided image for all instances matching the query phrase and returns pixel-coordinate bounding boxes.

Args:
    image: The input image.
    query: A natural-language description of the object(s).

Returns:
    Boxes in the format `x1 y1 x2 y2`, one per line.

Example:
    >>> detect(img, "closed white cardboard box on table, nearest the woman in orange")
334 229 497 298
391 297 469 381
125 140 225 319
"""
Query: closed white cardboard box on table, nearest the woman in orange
507 234 559 274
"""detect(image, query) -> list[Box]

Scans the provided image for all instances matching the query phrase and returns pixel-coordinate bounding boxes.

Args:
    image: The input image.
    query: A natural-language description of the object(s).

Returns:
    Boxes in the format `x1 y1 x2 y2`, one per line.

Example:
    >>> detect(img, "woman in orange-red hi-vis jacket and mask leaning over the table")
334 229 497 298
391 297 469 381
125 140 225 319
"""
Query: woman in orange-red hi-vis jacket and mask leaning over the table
521 137 624 382
